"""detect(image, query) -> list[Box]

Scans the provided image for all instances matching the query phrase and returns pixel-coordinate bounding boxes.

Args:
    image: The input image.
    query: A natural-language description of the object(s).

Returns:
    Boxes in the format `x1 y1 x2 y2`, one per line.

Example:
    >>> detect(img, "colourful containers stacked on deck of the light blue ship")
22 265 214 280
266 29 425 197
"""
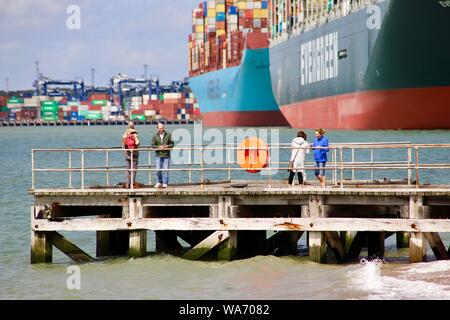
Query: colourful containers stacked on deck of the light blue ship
189 0 269 77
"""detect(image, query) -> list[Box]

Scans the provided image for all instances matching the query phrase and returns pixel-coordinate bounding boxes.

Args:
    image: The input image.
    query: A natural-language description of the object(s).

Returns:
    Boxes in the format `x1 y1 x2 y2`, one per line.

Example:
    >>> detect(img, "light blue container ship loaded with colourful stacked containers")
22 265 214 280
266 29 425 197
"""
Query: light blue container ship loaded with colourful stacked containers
189 0 287 127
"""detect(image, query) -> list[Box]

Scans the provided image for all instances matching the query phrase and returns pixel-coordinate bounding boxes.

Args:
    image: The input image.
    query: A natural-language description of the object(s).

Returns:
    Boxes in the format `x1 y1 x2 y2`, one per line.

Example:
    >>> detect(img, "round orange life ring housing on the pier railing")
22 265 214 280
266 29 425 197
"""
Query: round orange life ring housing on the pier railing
237 137 269 173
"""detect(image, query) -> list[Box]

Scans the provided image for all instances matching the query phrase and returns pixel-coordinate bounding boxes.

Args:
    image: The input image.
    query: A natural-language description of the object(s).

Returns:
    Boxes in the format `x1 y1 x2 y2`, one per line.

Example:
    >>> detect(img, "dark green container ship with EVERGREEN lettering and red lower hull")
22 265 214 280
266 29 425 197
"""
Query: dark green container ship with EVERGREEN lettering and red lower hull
269 0 450 130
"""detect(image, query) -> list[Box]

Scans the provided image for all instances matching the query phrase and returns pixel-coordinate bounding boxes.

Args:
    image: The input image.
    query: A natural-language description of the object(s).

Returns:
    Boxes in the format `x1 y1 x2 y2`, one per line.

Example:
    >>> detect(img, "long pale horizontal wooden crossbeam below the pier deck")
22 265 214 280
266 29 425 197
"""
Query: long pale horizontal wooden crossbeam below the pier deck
31 218 450 233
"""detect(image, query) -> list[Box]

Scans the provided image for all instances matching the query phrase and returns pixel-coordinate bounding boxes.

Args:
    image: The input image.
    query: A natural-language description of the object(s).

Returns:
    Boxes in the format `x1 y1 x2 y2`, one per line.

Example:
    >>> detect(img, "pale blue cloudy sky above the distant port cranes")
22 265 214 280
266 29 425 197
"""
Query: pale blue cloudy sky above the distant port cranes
0 0 199 90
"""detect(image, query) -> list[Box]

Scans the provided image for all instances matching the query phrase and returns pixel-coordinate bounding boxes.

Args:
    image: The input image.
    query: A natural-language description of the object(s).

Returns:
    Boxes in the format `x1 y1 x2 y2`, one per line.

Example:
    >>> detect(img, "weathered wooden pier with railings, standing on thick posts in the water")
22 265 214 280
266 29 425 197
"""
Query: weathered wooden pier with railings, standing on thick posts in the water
29 145 450 263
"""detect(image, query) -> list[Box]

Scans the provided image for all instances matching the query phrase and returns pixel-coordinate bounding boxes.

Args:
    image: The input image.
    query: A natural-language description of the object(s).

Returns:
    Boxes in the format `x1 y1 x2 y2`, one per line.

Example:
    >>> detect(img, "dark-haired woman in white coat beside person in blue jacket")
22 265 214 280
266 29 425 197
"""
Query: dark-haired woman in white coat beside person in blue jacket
289 131 309 186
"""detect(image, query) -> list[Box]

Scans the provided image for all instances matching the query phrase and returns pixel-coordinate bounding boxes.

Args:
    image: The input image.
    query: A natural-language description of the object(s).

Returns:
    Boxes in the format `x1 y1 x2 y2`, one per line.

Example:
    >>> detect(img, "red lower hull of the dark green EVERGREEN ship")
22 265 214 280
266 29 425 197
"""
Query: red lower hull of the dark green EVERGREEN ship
280 87 450 130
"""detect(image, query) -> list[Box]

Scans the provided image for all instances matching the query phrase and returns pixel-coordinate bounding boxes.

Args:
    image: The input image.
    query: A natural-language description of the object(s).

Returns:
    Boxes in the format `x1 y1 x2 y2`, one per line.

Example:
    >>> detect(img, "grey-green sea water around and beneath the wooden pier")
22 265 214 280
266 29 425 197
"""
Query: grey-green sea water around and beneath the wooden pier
0 126 450 300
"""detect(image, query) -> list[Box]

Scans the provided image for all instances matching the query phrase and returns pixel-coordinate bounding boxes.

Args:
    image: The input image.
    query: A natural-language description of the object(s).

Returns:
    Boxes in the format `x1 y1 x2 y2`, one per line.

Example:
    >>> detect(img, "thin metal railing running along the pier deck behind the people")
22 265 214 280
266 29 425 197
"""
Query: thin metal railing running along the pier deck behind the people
31 142 450 190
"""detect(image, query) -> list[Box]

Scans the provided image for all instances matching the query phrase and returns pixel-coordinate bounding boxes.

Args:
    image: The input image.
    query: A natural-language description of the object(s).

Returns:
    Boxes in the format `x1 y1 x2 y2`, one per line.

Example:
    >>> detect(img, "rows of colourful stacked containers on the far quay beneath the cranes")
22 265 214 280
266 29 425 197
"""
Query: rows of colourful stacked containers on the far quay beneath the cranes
0 92 200 121
